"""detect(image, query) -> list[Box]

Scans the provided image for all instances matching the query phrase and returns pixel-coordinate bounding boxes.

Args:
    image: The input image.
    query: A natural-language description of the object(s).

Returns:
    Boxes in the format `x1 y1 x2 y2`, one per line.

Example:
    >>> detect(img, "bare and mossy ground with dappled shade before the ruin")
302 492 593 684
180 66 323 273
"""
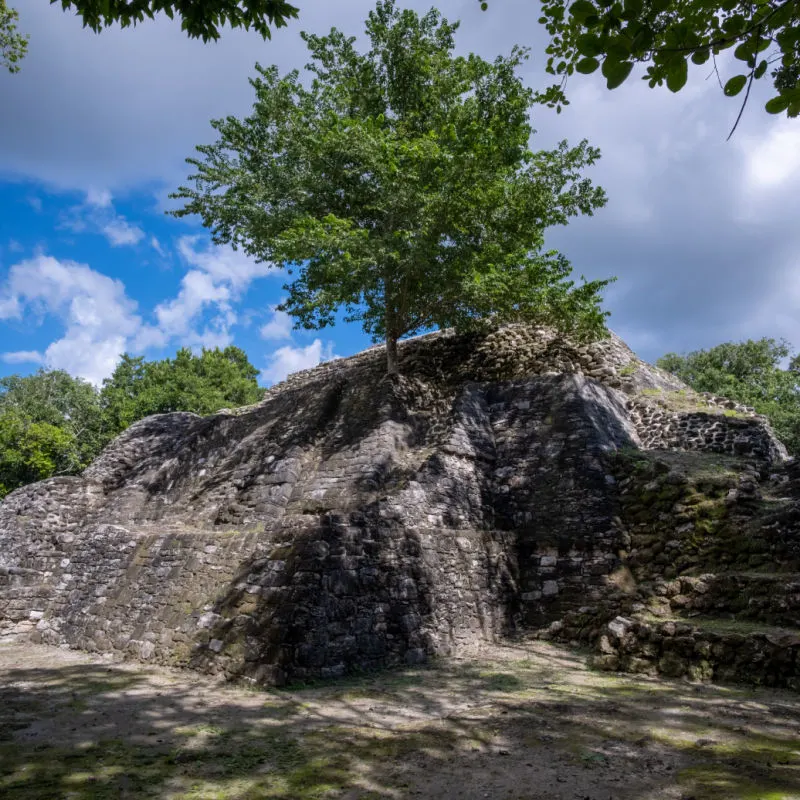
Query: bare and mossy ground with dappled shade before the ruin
0 642 800 800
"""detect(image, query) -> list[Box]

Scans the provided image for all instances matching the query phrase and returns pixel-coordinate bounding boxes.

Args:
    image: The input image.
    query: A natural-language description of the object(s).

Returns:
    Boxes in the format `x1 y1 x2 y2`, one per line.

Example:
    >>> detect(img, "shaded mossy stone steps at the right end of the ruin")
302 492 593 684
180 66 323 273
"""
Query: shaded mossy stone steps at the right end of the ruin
540 451 800 690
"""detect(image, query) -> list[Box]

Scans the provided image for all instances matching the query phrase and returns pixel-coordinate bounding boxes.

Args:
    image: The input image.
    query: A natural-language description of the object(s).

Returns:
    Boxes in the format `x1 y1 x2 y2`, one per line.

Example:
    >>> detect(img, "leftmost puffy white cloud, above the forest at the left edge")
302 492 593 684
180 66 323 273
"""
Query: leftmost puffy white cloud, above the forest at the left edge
0 254 141 385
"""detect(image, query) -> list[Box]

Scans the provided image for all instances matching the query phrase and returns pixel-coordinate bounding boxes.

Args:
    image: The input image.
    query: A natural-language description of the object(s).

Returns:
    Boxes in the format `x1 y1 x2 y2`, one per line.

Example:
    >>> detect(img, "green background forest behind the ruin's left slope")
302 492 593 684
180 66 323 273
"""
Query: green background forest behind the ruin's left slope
0 347 264 498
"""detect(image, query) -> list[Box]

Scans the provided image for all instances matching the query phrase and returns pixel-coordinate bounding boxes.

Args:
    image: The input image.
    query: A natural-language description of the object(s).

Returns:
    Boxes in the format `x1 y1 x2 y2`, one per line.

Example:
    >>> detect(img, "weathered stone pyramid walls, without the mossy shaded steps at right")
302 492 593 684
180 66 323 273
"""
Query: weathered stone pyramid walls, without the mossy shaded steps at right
0 326 782 682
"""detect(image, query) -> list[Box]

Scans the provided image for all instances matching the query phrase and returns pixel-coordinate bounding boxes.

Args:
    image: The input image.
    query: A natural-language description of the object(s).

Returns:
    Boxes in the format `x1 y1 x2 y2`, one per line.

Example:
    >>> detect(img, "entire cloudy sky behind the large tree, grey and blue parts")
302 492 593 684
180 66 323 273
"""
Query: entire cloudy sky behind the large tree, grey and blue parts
0 0 800 384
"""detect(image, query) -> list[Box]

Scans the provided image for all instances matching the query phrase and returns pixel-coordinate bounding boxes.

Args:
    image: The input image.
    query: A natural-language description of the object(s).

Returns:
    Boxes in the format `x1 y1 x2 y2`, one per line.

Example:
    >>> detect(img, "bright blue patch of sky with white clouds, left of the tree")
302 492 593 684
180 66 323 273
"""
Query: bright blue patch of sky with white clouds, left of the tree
0 180 370 384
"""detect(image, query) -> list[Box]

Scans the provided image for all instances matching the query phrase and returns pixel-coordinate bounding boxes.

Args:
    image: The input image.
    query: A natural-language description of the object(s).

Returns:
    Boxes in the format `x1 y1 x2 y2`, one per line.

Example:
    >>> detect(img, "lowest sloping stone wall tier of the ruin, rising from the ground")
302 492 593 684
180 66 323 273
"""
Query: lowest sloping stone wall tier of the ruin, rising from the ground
0 518 515 682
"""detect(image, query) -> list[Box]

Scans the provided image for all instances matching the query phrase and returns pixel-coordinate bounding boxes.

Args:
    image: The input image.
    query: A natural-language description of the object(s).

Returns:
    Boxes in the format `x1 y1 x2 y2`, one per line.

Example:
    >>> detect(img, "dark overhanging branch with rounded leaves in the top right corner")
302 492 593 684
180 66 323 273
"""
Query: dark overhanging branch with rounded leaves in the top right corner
520 0 800 133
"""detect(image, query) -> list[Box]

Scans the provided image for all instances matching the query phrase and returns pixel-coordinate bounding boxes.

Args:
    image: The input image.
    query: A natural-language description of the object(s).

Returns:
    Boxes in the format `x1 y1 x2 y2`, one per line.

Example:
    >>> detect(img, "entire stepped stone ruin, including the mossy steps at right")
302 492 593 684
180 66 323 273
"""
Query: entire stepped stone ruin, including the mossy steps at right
0 325 800 688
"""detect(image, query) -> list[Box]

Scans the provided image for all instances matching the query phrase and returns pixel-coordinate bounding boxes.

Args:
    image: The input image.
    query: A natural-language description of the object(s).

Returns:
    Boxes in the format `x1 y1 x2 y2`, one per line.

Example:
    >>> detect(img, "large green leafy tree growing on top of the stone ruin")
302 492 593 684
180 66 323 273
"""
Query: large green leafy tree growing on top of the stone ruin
169 0 608 372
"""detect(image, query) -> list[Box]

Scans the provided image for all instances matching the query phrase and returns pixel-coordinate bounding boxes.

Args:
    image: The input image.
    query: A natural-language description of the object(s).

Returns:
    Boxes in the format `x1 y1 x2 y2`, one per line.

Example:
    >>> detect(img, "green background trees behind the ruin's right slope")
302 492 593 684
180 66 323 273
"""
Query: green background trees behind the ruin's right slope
656 339 800 455
